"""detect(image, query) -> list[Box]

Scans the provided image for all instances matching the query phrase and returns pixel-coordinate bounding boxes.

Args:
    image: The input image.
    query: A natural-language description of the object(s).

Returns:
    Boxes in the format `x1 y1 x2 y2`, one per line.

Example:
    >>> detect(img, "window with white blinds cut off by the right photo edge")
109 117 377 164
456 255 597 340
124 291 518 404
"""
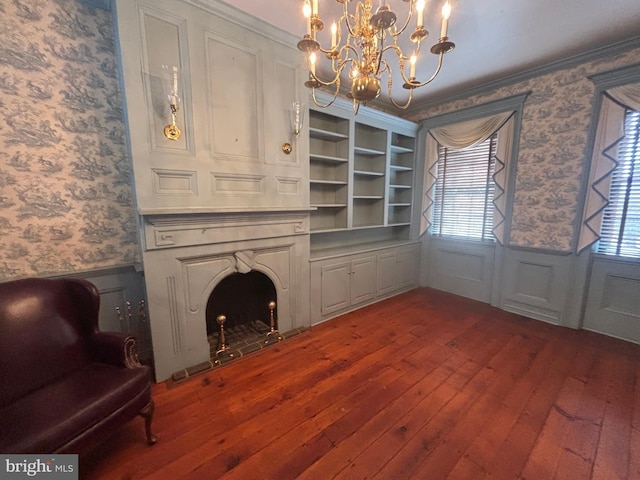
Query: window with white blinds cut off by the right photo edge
597 109 640 258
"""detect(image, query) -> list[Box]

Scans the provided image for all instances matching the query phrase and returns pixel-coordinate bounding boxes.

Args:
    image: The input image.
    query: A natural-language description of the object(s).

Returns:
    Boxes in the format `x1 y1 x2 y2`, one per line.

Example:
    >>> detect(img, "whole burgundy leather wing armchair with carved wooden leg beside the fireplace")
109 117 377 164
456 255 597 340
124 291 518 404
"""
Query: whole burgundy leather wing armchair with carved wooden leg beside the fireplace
0 278 156 453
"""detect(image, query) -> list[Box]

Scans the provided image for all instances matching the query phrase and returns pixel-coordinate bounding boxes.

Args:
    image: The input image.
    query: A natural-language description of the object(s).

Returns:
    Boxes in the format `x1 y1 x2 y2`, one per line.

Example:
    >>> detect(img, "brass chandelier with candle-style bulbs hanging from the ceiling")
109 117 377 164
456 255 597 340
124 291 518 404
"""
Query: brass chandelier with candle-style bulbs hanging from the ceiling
298 0 455 113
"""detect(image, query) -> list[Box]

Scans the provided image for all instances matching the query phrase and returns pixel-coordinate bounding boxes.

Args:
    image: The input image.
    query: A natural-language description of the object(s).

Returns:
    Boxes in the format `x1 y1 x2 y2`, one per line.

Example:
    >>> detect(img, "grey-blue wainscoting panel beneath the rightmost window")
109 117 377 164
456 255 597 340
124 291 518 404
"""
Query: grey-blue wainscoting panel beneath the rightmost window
583 257 640 343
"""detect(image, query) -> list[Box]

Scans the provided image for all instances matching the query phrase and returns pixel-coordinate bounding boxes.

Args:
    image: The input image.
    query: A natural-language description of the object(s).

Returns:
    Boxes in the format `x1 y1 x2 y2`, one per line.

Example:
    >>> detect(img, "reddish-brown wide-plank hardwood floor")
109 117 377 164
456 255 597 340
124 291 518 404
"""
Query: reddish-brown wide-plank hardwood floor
80 289 640 480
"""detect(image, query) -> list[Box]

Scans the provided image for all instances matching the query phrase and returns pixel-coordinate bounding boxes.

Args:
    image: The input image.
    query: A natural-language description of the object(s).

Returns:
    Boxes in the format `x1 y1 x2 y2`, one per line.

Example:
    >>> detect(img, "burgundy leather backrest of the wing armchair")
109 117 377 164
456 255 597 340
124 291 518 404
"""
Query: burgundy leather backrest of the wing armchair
0 278 100 406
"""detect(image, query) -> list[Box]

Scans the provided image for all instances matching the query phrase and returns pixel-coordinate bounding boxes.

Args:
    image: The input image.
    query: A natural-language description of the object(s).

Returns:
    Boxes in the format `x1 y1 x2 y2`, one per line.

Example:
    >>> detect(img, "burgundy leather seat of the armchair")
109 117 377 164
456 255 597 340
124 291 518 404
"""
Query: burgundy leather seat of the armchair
0 363 151 453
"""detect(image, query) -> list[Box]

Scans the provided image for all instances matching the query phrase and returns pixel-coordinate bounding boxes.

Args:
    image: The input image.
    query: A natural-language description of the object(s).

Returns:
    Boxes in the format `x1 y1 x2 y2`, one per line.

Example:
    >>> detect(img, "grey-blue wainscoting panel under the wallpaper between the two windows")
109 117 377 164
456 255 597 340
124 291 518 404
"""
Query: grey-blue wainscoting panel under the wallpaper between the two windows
500 248 571 325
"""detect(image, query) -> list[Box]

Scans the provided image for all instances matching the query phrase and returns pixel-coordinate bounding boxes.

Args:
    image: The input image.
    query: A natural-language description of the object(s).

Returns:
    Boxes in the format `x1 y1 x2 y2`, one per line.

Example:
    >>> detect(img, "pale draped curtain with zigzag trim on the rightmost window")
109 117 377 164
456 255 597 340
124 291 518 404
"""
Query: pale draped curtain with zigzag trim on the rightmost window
576 83 640 253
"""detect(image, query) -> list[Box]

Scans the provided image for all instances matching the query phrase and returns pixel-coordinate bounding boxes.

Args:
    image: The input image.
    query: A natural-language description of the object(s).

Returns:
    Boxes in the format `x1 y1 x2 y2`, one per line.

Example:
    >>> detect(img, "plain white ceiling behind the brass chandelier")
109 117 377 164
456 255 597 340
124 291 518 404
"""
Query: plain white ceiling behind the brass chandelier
216 0 640 110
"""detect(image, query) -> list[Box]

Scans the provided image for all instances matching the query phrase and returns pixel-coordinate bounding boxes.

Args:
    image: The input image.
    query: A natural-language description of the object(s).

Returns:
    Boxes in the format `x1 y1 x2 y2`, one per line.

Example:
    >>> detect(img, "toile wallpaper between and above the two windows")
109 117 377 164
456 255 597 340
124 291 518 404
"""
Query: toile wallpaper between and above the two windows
414 49 640 251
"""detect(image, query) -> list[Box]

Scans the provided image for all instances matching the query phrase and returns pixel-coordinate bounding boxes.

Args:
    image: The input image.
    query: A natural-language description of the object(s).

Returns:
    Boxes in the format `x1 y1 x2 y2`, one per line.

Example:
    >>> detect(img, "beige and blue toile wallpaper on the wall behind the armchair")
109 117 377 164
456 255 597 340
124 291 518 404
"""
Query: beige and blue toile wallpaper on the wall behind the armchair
0 0 138 280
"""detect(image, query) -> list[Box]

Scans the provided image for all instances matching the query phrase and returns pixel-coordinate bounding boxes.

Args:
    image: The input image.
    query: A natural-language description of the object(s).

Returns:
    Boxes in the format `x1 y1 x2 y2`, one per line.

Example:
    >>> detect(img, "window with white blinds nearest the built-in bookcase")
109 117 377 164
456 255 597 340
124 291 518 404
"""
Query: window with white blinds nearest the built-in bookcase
432 132 498 241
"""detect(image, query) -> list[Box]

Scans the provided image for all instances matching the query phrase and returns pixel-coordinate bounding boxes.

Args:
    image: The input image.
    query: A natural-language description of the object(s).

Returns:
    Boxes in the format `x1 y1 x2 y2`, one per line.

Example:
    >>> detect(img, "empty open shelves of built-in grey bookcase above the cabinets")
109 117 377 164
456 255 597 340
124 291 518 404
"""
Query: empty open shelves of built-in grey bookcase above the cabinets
309 95 417 255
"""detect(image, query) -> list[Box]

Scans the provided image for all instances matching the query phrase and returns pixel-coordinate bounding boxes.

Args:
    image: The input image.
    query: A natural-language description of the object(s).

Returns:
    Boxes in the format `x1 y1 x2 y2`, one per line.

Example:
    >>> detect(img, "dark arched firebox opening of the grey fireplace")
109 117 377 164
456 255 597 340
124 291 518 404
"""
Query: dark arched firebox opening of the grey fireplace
206 270 278 336
